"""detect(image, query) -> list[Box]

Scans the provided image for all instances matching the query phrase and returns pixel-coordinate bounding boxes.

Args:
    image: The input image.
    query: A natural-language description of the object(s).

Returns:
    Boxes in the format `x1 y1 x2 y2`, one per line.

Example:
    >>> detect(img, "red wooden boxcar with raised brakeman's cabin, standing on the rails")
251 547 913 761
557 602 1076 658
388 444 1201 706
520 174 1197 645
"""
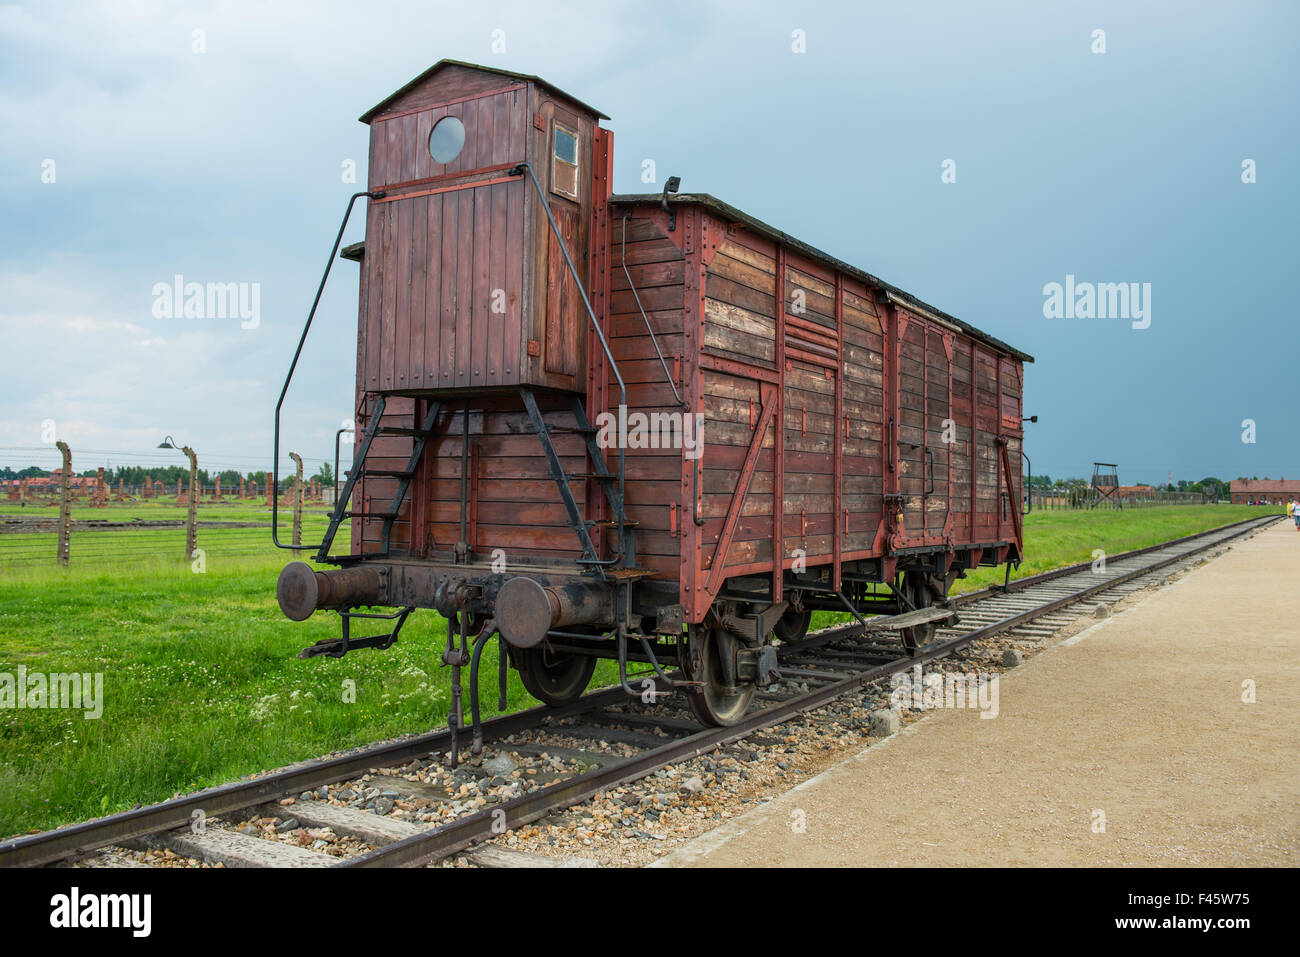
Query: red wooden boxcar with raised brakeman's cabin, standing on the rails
277 61 1031 723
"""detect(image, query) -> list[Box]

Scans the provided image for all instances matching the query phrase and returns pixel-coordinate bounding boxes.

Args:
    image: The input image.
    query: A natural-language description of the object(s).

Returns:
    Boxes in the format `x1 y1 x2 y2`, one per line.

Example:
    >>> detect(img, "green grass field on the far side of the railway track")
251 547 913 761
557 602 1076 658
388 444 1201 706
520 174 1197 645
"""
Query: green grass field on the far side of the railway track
0 505 1277 835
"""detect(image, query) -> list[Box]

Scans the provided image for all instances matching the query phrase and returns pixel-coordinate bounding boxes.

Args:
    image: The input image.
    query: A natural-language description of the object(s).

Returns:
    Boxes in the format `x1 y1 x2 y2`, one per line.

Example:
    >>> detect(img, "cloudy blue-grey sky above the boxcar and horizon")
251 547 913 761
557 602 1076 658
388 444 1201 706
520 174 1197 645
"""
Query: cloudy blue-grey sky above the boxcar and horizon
0 0 1300 482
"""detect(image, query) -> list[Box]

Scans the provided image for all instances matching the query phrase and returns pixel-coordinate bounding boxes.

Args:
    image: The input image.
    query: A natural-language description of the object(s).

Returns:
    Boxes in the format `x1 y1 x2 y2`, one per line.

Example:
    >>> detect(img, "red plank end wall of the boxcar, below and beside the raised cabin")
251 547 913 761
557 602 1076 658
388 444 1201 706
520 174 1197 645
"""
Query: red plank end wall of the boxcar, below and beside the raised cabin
354 218 685 577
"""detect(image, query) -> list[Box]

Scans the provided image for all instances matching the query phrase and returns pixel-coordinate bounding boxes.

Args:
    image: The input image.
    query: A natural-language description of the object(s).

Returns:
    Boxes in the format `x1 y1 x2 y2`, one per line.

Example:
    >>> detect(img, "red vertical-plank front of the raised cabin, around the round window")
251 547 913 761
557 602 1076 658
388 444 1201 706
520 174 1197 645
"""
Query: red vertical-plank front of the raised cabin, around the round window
360 88 527 391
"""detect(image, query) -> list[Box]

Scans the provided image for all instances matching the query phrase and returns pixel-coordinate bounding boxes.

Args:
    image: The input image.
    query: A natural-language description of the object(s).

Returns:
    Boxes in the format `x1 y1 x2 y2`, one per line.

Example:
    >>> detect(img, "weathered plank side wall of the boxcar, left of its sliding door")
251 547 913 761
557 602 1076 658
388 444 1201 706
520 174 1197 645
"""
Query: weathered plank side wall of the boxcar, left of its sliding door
701 235 884 568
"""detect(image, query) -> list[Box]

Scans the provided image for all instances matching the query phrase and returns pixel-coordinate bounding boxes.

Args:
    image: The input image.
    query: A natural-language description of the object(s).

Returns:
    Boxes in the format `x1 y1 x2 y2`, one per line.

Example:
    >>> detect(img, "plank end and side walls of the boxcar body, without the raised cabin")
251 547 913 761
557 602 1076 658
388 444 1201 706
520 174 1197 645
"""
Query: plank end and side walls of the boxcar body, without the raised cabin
354 200 1021 580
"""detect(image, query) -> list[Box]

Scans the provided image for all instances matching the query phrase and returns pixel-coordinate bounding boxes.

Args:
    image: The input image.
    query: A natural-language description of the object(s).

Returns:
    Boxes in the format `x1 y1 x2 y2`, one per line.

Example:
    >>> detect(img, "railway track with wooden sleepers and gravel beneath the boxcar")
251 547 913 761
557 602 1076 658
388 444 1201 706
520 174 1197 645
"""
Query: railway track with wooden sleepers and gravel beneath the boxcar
0 516 1279 867
